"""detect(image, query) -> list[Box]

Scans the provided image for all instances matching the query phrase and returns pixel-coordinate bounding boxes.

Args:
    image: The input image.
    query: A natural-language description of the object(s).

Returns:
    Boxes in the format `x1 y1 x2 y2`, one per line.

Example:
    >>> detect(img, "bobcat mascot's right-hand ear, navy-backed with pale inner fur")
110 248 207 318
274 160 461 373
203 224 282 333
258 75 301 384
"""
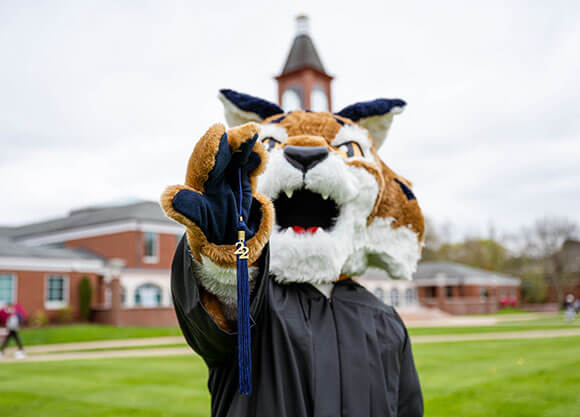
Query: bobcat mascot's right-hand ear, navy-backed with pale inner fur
336 98 407 149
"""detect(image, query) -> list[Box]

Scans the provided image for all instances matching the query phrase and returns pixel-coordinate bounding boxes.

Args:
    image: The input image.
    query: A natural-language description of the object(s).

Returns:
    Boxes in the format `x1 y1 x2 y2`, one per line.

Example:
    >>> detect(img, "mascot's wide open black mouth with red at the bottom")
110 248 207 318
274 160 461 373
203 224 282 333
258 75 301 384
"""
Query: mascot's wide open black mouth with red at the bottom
274 188 340 234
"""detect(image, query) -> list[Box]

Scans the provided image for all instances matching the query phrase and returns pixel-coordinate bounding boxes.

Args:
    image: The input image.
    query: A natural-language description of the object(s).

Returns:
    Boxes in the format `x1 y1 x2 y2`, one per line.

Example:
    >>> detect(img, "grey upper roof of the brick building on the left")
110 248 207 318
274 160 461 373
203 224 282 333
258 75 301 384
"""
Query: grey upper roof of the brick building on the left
6 201 175 240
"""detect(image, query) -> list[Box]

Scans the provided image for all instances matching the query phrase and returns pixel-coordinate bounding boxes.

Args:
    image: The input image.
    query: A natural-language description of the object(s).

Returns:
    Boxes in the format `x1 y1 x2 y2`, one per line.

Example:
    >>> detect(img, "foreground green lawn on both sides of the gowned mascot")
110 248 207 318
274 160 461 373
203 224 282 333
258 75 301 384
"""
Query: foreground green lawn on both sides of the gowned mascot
0 337 580 417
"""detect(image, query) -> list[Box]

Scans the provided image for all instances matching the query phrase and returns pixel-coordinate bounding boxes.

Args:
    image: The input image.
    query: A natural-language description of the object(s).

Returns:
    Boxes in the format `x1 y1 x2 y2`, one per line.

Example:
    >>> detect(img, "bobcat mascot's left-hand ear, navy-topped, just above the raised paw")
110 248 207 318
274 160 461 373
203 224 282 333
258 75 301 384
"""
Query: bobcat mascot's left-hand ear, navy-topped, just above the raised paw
218 89 284 127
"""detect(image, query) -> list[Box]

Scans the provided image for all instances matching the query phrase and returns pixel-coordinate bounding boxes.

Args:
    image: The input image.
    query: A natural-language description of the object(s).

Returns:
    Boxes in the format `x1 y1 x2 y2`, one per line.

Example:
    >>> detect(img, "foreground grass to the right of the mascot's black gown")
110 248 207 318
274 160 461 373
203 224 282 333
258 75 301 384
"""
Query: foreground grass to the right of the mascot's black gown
414 338 580 417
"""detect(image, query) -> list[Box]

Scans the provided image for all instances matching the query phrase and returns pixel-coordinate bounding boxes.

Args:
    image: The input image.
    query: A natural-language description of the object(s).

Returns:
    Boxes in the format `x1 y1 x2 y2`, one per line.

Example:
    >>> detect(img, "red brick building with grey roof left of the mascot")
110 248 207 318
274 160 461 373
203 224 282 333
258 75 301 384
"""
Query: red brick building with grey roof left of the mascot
0 201 183 325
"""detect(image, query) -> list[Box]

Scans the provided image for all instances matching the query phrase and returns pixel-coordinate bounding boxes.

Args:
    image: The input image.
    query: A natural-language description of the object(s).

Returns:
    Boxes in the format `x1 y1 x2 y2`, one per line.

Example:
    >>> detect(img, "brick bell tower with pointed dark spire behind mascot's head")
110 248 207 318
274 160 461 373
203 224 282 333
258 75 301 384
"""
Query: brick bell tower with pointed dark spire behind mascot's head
275 15 334 112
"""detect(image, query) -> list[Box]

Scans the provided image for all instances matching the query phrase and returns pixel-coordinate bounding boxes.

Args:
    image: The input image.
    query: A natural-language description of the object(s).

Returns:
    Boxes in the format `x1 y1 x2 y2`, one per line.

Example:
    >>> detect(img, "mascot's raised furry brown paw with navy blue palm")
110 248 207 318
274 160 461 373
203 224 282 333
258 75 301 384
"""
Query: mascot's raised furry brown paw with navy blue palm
161 123 273 268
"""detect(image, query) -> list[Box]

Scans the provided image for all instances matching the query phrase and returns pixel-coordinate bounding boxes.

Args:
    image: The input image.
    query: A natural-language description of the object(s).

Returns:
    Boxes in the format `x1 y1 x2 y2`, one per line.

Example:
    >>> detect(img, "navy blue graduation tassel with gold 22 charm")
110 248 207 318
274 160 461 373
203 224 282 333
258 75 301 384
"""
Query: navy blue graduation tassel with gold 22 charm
234 169 252 395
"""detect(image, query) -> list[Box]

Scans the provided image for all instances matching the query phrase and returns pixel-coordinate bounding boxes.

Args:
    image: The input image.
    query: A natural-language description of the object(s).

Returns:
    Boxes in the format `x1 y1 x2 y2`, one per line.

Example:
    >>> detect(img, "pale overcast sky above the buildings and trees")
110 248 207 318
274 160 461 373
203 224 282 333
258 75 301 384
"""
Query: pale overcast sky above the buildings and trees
0 0 580 234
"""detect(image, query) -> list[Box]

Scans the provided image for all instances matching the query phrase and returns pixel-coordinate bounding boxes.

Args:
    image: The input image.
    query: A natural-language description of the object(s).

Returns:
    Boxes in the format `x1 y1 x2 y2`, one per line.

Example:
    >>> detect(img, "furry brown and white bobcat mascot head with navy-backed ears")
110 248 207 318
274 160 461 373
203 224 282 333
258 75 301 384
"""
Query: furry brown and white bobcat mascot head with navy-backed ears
219 90 425 284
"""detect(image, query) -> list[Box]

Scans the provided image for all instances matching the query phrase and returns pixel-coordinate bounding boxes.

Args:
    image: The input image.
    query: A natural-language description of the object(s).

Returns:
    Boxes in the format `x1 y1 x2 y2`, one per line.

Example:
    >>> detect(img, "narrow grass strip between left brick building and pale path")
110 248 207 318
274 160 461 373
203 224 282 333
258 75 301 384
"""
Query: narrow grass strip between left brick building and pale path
20 324 181 346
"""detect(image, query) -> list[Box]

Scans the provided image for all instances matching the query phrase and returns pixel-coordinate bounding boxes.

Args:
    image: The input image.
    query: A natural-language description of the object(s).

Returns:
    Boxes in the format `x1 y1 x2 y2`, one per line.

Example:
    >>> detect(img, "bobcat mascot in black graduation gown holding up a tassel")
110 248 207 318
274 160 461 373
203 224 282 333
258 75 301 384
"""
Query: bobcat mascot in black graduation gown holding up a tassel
161 90 424 417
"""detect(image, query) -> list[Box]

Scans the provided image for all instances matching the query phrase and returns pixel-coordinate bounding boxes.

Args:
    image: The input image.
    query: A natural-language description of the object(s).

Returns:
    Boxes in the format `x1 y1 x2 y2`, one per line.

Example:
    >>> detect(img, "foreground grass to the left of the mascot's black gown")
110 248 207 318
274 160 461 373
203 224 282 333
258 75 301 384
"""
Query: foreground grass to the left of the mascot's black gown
0 355 209 417
